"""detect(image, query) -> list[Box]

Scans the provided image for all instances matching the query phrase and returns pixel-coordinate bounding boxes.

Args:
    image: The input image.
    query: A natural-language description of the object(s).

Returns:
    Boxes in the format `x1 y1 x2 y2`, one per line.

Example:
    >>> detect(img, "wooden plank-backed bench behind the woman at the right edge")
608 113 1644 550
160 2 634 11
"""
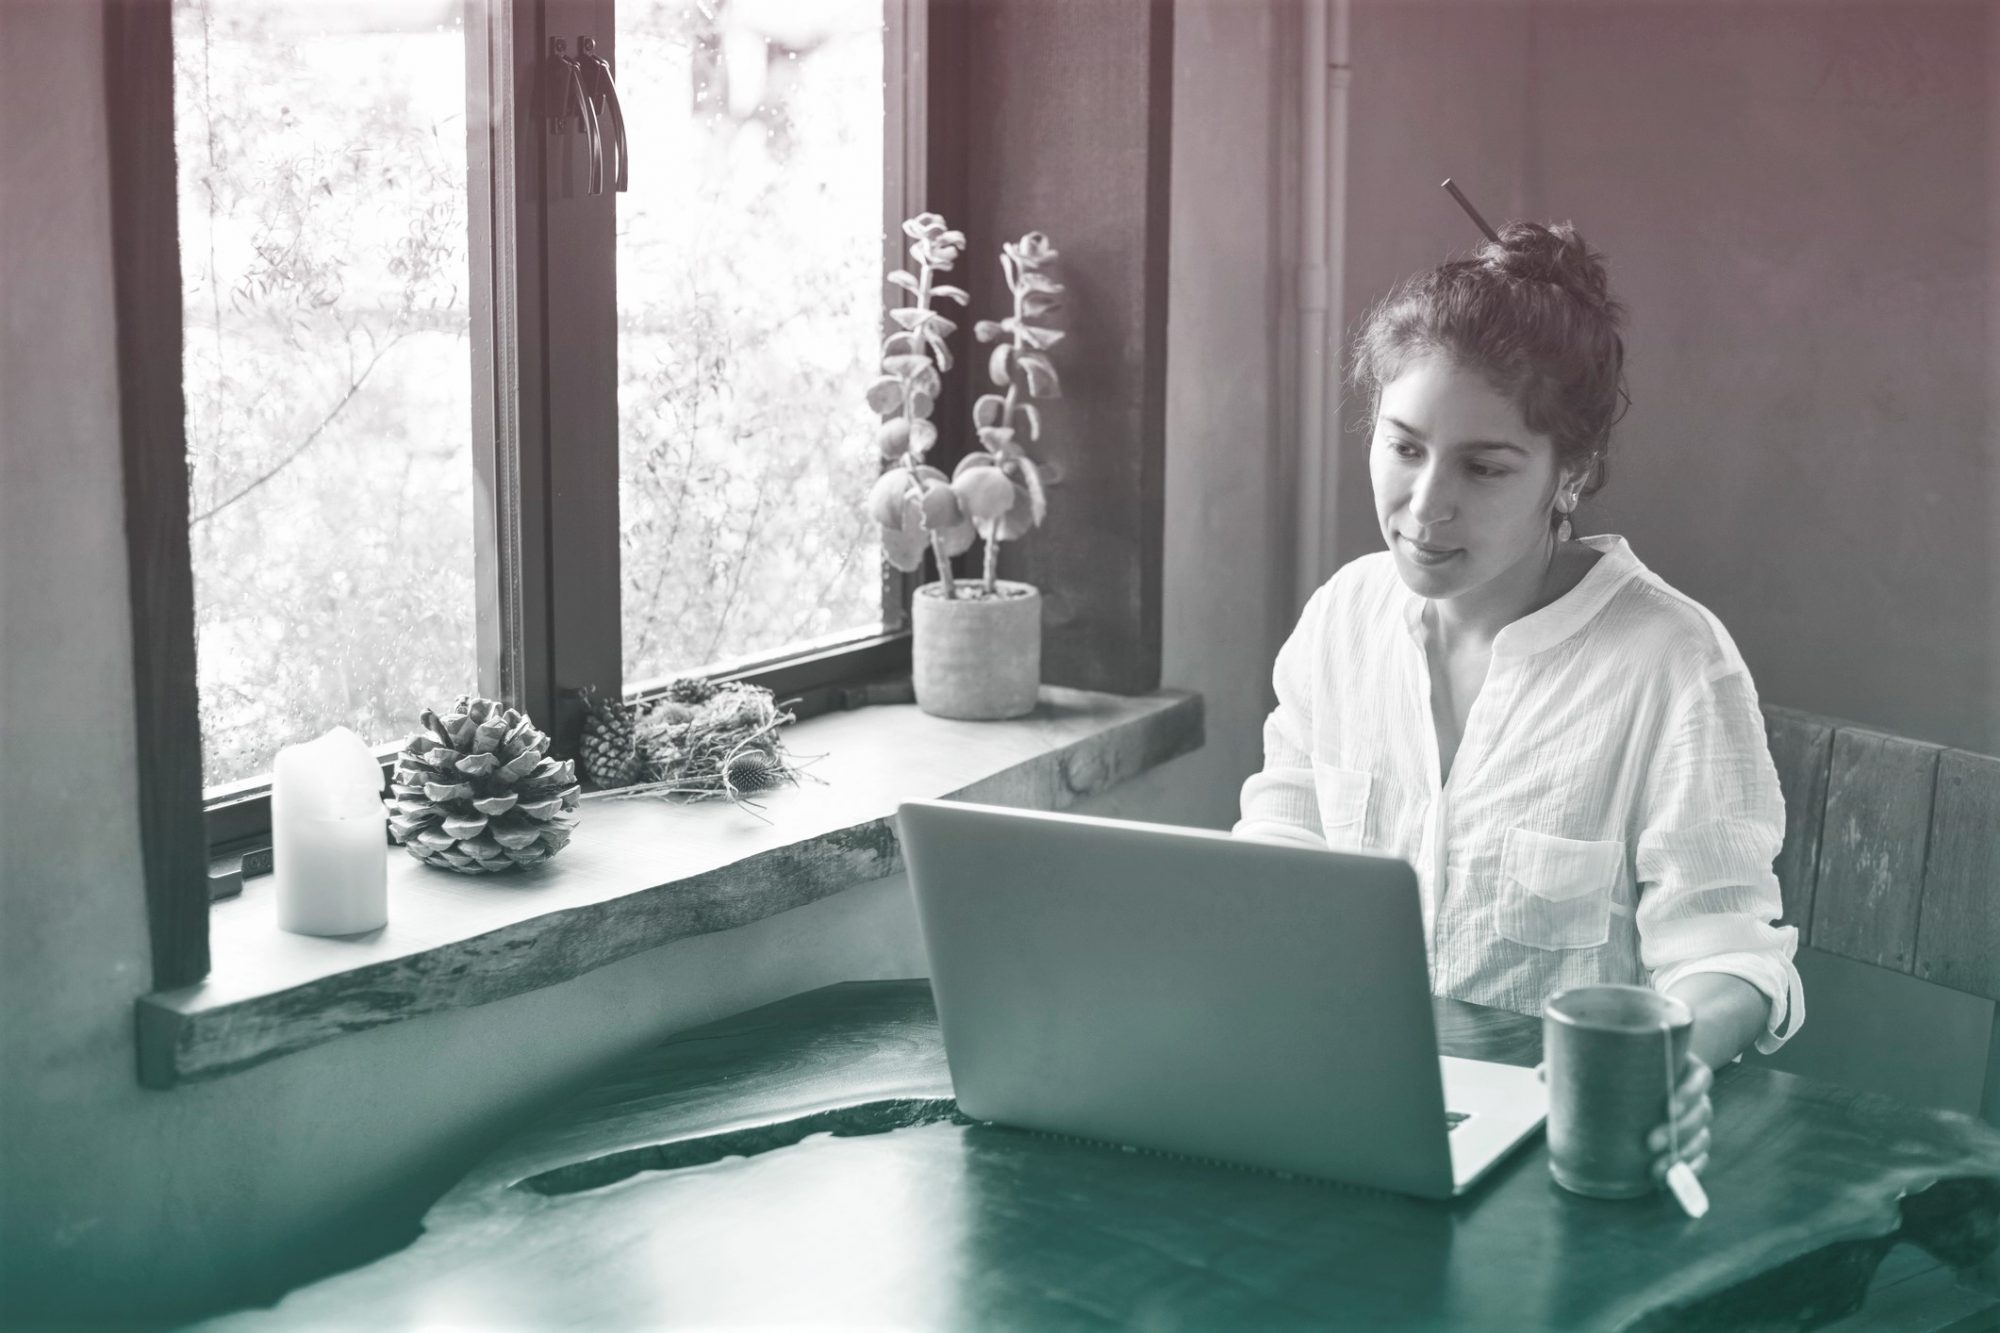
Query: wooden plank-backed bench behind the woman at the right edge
1744 709 2000 1125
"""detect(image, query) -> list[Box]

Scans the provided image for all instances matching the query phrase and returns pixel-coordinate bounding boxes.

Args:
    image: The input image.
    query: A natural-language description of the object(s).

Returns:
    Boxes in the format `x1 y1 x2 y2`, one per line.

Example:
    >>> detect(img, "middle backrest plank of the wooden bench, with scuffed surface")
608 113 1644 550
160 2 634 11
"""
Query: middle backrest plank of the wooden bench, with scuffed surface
1808 727 1942 973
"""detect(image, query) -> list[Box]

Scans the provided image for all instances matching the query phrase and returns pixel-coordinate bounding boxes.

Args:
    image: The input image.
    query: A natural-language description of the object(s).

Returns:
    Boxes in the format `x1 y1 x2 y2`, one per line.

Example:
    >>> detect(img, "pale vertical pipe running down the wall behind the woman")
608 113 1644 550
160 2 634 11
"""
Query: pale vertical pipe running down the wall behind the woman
1294 0 1350 604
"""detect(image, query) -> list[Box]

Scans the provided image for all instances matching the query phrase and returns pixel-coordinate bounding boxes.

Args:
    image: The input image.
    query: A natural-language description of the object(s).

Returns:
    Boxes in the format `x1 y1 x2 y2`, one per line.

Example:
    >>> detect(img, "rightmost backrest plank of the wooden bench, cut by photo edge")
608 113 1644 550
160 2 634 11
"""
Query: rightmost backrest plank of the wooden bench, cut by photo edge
1916 751 2000 1001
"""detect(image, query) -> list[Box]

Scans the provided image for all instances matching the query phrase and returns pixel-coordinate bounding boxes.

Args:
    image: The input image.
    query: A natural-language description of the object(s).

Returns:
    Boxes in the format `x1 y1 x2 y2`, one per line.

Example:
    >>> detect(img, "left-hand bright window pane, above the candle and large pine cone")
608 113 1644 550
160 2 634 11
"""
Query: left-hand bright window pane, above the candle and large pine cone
174 0 476 787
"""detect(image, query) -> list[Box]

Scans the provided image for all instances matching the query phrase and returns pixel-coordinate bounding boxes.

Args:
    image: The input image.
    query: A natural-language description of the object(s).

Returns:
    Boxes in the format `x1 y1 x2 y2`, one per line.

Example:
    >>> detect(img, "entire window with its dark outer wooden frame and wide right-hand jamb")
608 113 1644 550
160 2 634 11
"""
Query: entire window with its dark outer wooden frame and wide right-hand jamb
106 0 1172 989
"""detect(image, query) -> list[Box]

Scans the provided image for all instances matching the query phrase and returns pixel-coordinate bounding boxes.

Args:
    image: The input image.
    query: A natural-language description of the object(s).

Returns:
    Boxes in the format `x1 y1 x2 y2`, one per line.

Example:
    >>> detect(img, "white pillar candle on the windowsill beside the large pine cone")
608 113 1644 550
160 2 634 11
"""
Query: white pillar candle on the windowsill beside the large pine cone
270 727 388 935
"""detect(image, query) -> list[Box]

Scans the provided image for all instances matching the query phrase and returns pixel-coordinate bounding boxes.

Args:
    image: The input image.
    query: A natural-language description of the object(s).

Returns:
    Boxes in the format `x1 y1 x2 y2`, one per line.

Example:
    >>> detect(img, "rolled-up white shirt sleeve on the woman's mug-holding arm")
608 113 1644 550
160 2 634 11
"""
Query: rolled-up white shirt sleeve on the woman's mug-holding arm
1636 669 1806 1055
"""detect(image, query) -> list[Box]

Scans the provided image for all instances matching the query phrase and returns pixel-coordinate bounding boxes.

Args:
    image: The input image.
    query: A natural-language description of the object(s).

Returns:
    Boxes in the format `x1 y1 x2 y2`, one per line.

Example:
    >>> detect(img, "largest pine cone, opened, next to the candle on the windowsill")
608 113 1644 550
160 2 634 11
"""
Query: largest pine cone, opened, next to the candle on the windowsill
388 695 582 875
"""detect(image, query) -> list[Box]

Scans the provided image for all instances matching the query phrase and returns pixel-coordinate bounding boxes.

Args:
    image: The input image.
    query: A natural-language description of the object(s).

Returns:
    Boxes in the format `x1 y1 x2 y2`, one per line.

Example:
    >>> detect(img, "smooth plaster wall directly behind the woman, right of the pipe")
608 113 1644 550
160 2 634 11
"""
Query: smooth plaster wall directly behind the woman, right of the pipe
1336 0 2000 753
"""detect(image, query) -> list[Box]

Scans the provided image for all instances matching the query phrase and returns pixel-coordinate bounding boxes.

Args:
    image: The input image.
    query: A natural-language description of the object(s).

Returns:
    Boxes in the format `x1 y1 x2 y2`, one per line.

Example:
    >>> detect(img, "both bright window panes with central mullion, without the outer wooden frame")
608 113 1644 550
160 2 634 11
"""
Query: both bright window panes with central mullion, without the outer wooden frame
172 0 914 847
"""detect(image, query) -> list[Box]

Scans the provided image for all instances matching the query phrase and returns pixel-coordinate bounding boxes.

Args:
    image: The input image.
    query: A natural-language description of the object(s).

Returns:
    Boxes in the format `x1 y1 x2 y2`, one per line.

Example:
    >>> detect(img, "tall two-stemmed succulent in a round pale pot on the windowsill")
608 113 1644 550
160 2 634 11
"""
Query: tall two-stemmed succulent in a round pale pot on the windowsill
868 212 1062 719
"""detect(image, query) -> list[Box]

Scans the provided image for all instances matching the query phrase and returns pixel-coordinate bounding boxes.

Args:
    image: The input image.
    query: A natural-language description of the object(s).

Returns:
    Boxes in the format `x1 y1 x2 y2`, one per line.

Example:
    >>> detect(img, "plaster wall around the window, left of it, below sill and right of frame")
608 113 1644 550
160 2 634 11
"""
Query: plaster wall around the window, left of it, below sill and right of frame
0 0 1284 1323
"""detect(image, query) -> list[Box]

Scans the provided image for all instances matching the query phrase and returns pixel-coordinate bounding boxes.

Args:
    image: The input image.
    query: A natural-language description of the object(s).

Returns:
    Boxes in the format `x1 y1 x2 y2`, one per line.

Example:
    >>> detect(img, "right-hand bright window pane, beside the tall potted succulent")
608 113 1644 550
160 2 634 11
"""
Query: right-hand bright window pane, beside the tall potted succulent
618 0 884 687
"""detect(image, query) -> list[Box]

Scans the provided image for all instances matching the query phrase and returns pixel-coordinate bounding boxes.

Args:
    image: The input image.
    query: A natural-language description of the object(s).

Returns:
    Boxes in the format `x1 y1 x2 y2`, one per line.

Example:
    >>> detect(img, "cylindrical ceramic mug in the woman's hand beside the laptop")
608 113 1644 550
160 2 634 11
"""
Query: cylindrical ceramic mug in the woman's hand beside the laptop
1542 985 1694 1199
